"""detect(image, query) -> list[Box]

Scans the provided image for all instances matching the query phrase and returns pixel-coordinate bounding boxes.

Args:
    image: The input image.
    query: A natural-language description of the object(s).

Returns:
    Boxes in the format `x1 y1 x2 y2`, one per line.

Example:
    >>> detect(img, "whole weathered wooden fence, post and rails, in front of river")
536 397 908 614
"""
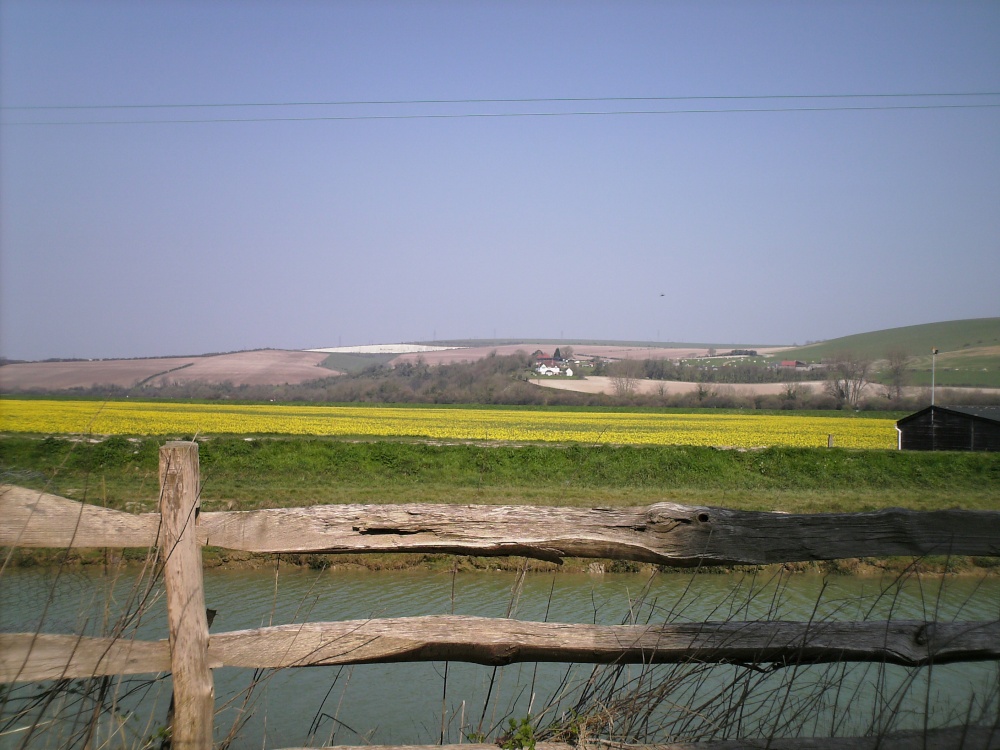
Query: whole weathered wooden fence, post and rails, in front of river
0 442 1000 750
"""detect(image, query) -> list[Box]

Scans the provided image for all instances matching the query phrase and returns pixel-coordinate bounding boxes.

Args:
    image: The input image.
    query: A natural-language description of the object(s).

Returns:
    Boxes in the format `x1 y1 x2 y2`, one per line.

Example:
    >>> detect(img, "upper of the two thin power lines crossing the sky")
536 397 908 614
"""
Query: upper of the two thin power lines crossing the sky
0 91 1000 111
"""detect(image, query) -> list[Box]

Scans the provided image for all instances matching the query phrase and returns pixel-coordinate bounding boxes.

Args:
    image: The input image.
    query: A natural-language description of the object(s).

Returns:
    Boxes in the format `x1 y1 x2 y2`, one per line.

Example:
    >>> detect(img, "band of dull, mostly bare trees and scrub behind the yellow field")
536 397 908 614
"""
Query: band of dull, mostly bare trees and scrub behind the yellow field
5 352 989 410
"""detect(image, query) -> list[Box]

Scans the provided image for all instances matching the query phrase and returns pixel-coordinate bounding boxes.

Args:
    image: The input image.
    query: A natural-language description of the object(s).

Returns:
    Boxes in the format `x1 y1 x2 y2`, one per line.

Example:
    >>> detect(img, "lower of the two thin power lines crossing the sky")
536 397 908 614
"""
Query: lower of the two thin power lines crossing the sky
2 102 1000 126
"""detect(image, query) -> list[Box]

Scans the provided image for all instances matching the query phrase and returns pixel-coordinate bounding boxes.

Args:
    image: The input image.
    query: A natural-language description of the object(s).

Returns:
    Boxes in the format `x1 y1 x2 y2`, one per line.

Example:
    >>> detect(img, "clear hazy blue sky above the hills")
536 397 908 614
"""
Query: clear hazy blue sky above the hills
0 0 1000 359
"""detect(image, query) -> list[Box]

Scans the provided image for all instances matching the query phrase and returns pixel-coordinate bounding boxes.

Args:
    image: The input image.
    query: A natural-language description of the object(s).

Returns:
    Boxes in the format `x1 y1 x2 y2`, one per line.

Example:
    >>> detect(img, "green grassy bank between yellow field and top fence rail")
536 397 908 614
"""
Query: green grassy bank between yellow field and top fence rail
0 437 1000 513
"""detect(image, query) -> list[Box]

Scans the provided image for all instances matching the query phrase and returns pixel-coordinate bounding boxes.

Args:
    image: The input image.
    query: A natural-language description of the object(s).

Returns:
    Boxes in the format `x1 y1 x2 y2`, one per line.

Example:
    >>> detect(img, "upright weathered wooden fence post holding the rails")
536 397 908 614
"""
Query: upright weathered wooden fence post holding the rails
160 441 215 750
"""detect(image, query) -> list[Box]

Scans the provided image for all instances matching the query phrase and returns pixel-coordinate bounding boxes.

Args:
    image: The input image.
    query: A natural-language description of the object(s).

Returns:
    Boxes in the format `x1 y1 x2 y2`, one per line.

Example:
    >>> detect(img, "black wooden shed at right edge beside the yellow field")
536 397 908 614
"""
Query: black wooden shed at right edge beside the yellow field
896 406 1000 451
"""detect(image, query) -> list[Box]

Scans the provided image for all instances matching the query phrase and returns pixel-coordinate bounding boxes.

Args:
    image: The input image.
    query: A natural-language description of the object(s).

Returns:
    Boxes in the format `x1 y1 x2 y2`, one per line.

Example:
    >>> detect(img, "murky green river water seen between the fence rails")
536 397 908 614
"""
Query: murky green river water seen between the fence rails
0 567 1000 748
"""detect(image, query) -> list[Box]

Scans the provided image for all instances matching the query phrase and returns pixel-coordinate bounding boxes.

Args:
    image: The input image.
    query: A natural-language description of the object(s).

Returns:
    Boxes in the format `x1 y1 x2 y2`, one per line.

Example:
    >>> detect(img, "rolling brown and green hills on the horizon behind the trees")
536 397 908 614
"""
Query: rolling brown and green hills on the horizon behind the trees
0 317 1000 392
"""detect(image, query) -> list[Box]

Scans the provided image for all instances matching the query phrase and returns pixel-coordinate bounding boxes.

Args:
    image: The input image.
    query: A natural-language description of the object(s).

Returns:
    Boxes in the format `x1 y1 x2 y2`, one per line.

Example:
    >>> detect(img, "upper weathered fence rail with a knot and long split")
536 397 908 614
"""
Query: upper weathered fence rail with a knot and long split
0 486 1000 567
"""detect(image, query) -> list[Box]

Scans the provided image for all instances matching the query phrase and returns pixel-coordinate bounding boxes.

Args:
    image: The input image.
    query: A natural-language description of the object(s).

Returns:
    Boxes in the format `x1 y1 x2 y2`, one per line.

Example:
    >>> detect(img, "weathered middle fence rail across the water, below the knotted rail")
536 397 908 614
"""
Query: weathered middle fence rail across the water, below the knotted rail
0 615 1000 681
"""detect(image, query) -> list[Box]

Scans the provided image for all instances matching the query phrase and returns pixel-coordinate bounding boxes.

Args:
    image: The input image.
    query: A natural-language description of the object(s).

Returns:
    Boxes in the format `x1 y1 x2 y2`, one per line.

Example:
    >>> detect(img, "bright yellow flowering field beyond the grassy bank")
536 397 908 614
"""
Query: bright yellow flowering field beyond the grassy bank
0 399 896 448
